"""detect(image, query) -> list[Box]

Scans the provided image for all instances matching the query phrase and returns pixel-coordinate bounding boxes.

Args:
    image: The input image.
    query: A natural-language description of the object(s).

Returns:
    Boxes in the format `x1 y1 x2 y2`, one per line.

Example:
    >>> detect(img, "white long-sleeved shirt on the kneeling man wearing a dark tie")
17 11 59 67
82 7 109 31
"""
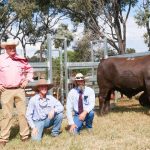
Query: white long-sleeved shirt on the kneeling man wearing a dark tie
66 86 95 125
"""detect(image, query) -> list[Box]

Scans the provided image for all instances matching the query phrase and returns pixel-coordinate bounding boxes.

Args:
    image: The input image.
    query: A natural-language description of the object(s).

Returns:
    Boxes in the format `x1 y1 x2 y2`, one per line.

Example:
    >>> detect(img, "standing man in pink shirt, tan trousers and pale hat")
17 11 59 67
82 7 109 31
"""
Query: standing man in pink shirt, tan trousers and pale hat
0 39 33 147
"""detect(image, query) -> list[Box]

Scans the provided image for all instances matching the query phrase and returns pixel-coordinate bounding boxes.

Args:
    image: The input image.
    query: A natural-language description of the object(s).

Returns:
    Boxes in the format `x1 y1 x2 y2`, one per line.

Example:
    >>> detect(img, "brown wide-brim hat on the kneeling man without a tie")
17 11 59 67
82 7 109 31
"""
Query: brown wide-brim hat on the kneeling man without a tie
33 79 54 91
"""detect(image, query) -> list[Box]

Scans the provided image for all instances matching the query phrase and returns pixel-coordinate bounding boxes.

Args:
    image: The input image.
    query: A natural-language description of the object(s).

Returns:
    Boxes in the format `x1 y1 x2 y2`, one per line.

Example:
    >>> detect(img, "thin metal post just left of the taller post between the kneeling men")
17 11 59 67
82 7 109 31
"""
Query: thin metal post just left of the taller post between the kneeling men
59 48 64 105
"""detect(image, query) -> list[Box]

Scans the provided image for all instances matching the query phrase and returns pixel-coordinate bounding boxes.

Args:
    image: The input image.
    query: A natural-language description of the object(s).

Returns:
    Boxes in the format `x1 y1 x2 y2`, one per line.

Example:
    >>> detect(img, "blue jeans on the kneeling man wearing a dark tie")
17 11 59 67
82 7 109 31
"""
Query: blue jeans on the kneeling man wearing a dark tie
73 110 94 133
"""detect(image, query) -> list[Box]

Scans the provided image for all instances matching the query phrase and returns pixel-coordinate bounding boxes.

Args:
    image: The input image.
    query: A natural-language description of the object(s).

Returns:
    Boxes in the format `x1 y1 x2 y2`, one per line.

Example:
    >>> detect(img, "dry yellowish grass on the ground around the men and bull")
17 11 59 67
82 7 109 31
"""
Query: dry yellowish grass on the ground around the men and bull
0 100 150 150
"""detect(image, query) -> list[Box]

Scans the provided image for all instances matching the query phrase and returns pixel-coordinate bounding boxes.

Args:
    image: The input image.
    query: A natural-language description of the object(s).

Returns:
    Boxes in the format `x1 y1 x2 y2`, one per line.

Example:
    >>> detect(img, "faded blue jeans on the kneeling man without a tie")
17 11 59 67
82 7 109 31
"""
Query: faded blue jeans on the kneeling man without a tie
31 113 63 141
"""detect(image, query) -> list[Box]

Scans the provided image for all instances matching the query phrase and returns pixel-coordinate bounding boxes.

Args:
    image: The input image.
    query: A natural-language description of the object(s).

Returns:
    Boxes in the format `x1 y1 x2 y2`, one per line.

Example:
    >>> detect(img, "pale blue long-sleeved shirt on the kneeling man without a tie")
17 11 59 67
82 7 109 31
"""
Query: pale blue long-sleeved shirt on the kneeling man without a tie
26 94 64 128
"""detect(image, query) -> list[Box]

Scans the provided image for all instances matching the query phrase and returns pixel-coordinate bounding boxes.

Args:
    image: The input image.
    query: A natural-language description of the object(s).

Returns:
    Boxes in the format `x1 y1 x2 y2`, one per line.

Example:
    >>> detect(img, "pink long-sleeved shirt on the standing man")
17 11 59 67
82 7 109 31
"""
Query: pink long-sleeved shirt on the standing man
0 53 33 88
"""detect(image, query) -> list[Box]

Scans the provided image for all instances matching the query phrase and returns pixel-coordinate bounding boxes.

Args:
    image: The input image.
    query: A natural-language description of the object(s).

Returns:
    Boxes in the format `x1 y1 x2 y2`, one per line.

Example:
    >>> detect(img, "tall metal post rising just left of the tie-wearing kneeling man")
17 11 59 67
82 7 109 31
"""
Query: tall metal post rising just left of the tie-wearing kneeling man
64 38 68 97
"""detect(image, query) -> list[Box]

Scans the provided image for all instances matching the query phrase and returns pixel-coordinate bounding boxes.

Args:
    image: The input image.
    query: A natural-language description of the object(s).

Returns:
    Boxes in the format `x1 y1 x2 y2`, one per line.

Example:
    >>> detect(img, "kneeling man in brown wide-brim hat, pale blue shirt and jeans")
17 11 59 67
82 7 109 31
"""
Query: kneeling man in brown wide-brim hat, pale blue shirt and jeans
26 79 64 141
